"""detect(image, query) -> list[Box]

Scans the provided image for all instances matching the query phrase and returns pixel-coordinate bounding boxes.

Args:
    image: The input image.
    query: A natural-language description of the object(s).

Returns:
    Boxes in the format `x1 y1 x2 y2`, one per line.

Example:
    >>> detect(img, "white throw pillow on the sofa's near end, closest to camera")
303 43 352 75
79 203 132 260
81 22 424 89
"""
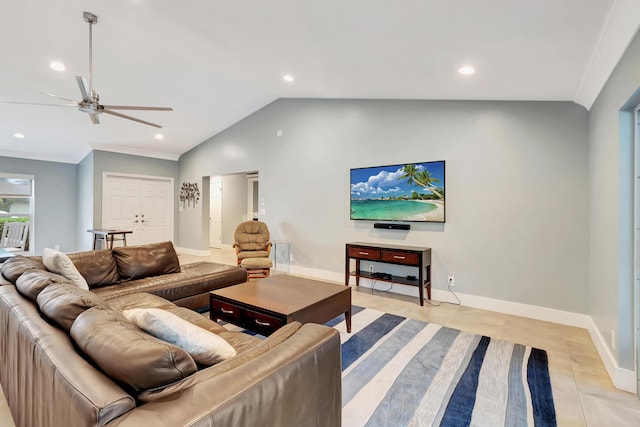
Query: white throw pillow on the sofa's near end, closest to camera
122 308 236 365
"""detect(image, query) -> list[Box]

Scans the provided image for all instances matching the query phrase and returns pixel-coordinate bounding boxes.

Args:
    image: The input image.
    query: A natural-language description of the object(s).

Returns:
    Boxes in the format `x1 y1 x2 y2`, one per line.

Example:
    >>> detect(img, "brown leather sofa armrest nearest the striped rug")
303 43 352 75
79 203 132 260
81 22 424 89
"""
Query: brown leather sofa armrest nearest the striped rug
108 324 342 427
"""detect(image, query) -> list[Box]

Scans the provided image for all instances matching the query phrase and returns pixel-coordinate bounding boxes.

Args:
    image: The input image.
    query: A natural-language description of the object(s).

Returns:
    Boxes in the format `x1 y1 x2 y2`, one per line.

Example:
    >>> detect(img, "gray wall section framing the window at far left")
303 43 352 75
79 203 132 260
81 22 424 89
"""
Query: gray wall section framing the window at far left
0 157 78 255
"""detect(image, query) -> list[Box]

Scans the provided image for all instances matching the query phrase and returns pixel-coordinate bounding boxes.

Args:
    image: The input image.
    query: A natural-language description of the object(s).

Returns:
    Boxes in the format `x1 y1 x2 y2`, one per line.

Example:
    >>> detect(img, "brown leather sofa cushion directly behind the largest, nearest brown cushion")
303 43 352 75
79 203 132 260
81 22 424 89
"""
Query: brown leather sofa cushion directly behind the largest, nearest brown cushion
36 283 107 333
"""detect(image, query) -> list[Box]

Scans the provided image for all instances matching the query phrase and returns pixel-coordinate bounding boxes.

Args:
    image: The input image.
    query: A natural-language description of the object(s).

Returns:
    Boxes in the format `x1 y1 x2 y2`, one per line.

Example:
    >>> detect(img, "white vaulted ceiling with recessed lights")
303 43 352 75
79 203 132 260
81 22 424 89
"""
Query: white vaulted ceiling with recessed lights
0 0 640 163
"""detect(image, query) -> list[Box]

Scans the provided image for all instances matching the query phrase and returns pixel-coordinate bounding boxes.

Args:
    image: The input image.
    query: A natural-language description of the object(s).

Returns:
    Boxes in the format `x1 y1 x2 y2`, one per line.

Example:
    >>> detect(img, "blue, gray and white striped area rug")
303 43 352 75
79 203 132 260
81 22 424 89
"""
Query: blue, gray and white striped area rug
327 306 556 427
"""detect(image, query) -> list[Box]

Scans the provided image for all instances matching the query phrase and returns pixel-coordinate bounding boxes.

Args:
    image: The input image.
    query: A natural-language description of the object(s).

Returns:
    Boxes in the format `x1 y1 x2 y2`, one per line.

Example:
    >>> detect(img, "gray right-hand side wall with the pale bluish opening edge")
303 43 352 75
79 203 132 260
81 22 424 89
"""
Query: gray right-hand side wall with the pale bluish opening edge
589 30 640 369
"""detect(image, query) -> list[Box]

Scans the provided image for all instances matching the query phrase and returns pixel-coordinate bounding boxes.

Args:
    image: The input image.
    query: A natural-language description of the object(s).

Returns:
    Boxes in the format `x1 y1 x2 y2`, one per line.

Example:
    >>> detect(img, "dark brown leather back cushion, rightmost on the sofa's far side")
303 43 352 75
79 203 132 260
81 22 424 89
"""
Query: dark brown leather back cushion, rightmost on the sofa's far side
113 242 180 280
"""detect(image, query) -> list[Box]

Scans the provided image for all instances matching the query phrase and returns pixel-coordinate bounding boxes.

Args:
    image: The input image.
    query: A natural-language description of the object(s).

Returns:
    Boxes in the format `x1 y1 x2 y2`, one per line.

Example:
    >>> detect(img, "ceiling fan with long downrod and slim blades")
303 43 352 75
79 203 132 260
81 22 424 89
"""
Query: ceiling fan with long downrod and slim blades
5 12 173 128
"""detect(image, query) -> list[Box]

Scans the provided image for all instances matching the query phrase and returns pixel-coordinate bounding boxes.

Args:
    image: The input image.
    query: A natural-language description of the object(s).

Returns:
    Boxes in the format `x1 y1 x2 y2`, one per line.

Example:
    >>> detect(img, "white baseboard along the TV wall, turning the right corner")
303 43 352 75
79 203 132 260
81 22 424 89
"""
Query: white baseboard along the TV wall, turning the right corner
291 266 637 393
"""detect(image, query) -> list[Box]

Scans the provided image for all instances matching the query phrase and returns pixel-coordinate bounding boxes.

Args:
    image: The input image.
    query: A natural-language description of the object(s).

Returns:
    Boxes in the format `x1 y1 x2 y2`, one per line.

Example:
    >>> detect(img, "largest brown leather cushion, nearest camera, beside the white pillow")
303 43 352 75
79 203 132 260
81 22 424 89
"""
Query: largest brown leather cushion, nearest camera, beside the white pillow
71 307 197 393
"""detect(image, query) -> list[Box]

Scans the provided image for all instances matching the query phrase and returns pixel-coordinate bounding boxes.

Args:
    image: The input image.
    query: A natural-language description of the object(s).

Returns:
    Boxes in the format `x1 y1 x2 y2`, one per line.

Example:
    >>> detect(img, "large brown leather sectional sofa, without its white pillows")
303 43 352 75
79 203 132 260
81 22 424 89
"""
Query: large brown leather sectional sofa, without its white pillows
0 244 341 427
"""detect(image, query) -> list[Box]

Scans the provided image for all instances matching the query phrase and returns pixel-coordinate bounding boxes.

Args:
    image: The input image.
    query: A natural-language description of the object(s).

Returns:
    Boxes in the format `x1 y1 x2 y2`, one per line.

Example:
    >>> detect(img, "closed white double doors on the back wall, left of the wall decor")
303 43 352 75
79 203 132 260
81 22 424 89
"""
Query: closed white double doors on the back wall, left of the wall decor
102 173 173 245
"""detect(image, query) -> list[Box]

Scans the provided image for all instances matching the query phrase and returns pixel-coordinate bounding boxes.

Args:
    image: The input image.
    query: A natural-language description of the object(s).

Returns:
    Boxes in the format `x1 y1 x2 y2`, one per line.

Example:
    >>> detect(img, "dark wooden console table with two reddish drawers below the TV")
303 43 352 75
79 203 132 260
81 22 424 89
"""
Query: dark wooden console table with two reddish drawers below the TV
344 242 431 305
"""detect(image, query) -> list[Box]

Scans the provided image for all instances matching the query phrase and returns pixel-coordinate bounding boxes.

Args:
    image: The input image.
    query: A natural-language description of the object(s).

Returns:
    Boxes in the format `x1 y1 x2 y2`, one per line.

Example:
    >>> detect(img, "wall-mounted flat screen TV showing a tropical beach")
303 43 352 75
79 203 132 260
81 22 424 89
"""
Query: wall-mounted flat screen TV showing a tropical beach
351 161 445 222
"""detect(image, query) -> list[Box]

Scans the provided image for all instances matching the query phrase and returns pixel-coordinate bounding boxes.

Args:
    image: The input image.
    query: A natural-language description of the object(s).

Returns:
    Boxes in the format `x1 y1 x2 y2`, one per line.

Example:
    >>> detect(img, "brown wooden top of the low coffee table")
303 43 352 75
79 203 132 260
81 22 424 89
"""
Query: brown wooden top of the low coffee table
211 274 351 316
